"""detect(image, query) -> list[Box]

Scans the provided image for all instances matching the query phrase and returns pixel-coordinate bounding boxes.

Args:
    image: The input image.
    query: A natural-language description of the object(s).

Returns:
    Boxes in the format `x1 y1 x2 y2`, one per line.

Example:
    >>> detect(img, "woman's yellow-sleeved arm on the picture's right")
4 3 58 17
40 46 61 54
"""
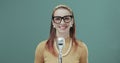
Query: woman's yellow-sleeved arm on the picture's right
80 43 88 63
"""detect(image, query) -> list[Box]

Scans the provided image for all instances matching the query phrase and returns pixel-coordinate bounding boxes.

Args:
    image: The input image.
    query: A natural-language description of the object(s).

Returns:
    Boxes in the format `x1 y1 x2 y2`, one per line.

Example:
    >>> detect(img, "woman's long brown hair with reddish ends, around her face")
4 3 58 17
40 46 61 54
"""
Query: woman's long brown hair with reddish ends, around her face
46 5 78 56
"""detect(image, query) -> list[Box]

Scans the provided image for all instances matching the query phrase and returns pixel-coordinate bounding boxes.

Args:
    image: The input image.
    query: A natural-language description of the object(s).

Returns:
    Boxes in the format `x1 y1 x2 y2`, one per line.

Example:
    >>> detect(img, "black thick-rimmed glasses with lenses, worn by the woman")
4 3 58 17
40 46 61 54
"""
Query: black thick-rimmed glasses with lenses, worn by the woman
52 15 73 24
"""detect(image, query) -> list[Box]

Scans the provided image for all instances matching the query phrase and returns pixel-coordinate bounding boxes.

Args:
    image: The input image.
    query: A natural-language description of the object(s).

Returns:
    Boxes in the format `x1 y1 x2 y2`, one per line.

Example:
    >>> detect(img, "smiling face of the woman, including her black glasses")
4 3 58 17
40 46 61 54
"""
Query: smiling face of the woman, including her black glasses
52 8 73 32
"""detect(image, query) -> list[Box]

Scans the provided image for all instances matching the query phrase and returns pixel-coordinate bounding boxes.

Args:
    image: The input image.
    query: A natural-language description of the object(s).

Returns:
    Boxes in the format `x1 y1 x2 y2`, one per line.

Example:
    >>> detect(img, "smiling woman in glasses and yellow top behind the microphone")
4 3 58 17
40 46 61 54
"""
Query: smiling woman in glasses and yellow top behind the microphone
34 5 88 63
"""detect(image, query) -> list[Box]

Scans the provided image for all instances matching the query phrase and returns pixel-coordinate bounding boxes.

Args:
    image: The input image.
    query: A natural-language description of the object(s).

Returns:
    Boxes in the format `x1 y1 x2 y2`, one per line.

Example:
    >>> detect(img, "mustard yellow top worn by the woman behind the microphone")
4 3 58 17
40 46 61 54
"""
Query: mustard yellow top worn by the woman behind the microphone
34 41 88 63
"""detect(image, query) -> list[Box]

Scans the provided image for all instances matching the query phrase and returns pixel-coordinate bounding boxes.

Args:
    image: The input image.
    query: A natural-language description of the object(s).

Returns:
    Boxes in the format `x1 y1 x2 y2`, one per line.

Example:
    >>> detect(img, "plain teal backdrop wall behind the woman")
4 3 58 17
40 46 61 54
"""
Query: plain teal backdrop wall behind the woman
0 0 120 63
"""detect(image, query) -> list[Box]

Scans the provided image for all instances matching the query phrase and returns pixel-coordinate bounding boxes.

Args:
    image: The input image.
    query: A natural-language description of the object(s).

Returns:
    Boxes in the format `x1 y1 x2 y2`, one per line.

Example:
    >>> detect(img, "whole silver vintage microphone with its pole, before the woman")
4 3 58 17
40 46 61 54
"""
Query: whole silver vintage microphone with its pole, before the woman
57 37 65 63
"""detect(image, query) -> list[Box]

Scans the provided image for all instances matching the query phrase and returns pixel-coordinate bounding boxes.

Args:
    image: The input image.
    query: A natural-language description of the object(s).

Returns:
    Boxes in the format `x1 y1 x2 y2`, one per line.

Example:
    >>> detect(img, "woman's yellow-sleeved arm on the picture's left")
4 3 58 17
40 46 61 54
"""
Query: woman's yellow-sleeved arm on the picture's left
34 43 44 63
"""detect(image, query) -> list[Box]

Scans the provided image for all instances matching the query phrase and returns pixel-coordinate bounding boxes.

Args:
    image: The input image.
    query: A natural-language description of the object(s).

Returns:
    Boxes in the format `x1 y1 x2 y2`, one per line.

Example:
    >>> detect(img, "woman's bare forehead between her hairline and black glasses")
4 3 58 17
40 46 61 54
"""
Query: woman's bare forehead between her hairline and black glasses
54 8 71 16
